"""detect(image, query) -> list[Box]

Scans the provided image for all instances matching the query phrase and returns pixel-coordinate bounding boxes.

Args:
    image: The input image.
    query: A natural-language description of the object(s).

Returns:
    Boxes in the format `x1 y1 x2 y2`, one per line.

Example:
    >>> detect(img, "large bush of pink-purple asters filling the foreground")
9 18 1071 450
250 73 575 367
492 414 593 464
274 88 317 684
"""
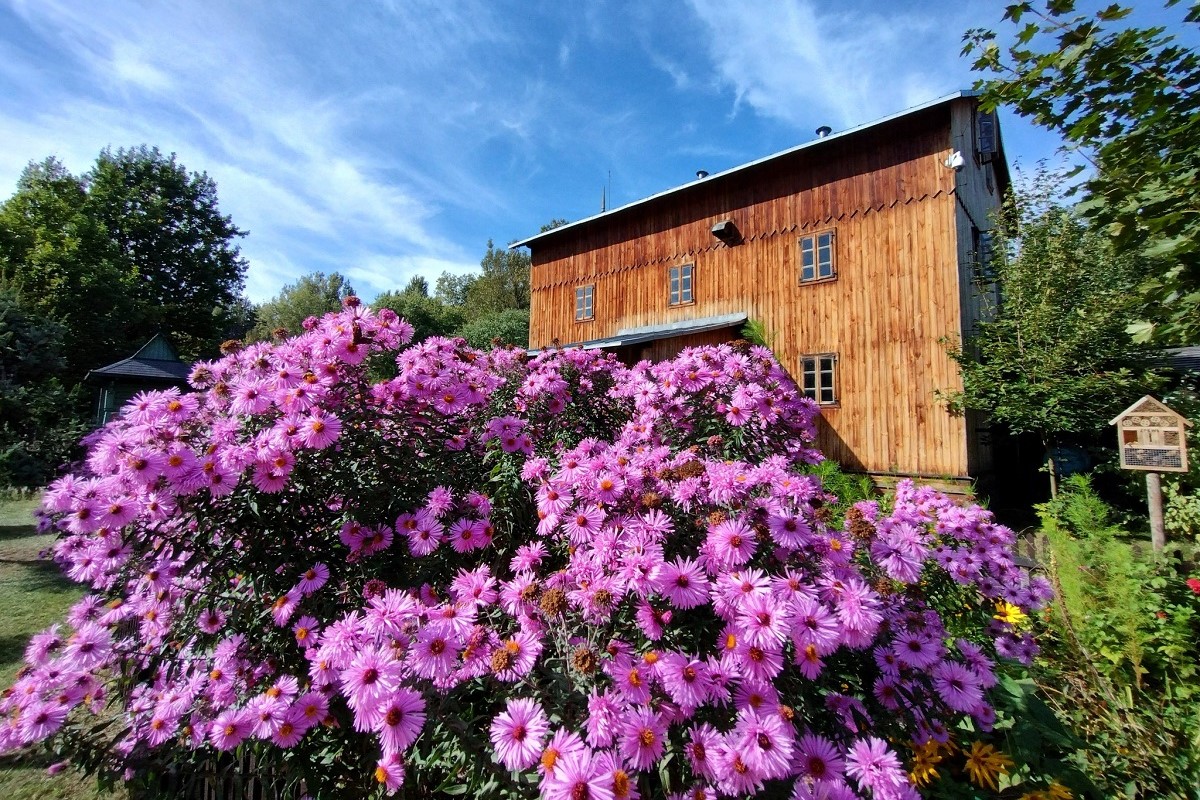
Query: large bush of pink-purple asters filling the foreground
0 301 1049 800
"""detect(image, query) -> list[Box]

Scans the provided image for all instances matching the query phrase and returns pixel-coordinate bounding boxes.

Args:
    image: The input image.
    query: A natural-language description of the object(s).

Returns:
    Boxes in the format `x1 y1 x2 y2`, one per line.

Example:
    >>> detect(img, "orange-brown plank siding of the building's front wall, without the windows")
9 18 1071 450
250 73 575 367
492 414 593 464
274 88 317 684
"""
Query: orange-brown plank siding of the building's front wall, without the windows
529 95 1003 479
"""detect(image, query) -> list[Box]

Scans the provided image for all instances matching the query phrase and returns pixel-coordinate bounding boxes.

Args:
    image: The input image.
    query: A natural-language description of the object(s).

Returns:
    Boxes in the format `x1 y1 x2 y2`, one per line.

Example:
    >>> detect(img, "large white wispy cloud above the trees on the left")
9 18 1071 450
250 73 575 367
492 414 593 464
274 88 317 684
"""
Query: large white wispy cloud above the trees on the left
0 0 520 300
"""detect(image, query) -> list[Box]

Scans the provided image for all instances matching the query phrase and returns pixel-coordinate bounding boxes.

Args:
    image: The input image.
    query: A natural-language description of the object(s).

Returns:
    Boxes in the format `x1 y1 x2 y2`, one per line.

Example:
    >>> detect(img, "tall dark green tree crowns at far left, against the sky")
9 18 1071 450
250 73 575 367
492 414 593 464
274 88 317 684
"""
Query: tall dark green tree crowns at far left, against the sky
0 146 246 369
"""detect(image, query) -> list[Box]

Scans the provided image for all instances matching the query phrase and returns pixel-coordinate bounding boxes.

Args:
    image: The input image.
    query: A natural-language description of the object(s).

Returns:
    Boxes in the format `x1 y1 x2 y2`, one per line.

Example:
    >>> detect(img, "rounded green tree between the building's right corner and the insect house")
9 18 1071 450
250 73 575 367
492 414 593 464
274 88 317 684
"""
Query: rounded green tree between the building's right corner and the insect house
949 191 1152 494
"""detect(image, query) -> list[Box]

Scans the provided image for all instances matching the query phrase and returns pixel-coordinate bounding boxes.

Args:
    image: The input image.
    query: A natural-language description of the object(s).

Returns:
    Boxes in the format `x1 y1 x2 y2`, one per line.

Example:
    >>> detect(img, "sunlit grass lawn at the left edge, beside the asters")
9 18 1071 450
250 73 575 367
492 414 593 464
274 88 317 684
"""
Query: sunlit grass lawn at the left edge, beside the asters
0 500 124 800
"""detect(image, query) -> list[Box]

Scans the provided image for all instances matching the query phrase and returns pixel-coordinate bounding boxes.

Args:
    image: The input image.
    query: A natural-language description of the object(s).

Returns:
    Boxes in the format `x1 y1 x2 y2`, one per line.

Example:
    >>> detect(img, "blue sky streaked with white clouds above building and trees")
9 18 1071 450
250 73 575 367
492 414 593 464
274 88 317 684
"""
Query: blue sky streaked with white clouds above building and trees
0 0 1190 301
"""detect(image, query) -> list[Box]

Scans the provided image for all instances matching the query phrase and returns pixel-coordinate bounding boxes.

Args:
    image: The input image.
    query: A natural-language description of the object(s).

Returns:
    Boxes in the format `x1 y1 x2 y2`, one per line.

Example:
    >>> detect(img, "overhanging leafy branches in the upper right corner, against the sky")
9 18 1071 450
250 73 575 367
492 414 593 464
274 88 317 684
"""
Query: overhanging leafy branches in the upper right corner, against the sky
964 0 1200 343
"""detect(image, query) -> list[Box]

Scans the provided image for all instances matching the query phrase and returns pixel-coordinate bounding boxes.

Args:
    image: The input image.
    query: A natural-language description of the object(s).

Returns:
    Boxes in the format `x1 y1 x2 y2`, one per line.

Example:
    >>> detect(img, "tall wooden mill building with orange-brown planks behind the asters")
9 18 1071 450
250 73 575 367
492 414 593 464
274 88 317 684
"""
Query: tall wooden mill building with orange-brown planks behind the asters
512 91 1009 485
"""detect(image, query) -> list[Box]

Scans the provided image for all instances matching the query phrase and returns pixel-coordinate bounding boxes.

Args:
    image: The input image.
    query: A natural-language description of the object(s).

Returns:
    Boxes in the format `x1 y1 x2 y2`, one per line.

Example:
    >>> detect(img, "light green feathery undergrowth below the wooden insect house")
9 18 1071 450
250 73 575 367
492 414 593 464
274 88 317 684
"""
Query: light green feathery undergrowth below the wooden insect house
1036 476 1200 799
